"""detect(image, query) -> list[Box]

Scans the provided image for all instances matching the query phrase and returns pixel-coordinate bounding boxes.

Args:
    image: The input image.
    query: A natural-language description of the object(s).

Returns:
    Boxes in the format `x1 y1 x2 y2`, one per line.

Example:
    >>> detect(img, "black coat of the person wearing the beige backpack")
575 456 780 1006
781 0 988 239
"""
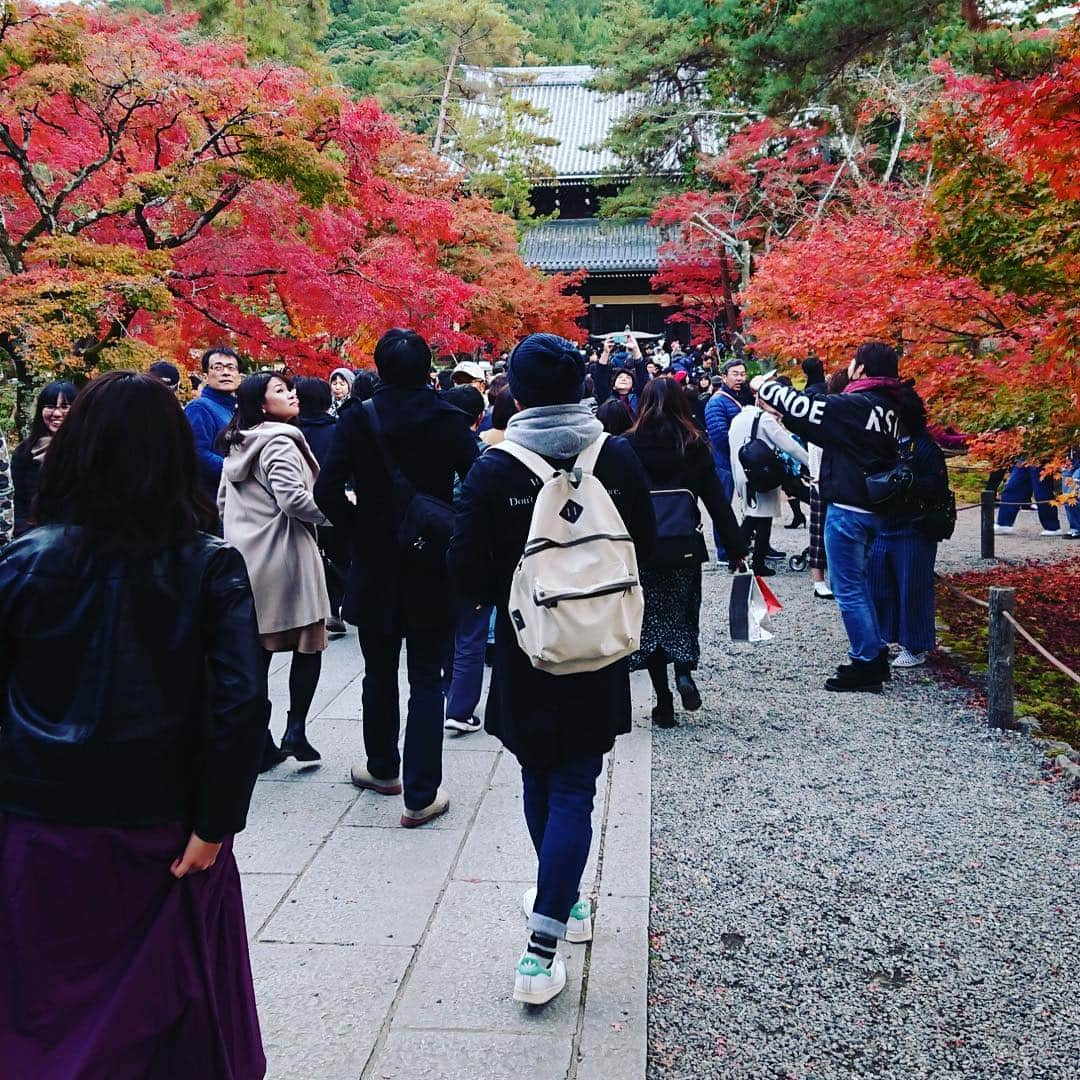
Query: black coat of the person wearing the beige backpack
448 429 656 769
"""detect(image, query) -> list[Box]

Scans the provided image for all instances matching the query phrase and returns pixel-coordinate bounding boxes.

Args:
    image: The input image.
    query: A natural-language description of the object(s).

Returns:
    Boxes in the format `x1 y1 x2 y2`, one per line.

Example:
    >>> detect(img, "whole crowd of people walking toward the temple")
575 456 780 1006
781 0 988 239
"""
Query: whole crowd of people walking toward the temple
0 329 1080 1078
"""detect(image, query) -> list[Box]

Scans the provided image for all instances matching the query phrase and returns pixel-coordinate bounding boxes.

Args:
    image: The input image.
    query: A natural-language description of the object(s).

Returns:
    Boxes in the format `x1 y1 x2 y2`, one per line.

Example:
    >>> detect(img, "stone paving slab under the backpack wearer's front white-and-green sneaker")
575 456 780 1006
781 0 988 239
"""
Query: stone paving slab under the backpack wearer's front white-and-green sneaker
391 880 585 1036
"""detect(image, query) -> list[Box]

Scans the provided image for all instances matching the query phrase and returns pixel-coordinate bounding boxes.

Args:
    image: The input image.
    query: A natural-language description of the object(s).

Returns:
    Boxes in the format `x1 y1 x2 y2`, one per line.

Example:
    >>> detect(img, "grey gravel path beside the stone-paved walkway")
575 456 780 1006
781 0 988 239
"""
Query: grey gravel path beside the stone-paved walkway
649 511 1080 1080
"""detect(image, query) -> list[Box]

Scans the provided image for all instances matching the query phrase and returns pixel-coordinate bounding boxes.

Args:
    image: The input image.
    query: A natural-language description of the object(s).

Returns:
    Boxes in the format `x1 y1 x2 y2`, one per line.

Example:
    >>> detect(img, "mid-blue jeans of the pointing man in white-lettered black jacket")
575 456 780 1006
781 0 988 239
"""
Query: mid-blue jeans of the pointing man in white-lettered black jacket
825 503 886 660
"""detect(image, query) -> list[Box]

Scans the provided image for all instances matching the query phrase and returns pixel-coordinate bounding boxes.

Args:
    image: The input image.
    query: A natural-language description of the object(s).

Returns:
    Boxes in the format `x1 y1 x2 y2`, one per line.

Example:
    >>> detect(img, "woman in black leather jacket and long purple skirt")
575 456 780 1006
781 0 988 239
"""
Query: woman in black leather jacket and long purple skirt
0 372 266 1080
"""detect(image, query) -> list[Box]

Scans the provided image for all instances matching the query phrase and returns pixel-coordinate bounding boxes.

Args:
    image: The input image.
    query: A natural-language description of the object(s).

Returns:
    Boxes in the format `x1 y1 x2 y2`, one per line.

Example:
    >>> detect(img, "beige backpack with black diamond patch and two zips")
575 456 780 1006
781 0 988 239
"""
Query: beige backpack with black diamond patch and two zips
492 434 645 675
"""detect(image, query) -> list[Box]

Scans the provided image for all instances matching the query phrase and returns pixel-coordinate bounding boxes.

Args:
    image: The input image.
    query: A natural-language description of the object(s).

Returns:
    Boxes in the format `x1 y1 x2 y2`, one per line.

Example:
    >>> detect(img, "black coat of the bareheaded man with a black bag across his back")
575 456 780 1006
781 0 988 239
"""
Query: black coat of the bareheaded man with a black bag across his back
315 384 476 634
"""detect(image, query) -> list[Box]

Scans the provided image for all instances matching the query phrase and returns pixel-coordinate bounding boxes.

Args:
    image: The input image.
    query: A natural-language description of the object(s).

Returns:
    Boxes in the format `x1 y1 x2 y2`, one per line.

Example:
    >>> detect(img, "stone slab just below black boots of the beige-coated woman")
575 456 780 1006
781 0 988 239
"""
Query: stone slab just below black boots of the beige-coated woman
235 783 359 874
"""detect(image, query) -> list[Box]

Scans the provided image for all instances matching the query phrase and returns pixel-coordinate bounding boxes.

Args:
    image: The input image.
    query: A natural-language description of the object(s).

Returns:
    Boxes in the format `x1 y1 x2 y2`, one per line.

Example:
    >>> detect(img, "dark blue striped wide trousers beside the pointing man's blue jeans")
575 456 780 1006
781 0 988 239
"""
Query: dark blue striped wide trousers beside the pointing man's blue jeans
869 525 937 652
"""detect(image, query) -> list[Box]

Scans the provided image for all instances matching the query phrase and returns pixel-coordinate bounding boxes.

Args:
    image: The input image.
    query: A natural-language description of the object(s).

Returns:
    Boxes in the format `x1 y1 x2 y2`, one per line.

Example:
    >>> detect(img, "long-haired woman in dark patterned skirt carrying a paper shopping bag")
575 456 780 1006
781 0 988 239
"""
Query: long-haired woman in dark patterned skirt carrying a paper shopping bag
626 379 746 728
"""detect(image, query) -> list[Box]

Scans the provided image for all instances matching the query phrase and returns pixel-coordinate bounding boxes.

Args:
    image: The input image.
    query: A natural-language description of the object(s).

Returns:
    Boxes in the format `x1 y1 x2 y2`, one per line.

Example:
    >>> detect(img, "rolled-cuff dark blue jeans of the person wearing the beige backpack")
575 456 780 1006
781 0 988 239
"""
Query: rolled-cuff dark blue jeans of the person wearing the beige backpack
522 756 604 937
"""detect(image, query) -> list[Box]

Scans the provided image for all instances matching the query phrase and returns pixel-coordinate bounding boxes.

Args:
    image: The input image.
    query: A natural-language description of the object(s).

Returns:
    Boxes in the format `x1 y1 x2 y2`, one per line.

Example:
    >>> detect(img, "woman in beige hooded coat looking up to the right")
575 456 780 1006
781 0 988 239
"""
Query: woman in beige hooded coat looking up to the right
217 372 330 769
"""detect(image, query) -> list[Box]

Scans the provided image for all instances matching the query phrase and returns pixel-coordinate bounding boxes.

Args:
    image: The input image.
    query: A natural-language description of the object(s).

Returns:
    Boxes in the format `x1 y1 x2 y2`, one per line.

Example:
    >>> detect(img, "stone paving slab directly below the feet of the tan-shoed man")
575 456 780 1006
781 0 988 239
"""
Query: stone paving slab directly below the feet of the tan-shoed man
261 825 462 946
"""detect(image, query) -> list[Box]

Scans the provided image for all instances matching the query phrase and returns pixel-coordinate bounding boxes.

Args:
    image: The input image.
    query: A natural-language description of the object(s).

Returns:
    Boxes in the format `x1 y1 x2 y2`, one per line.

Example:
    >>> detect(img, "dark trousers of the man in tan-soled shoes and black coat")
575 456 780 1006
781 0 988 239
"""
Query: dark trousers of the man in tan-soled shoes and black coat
360 630 448 810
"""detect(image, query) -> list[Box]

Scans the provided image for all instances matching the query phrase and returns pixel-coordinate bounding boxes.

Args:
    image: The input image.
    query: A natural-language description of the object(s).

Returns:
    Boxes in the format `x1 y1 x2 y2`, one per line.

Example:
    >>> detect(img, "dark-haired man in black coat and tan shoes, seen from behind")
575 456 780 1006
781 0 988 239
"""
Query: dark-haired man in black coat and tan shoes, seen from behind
315 329 476 827
